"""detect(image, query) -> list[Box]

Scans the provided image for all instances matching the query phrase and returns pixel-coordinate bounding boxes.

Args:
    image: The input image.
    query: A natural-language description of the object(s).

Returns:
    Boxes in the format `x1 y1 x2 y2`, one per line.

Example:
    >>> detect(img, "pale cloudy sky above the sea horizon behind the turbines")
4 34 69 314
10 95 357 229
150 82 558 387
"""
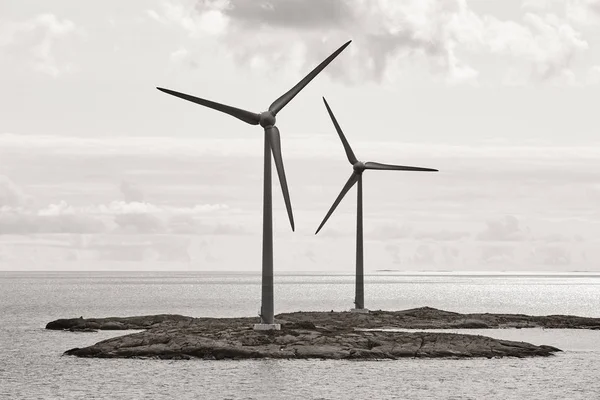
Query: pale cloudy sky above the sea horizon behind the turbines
0 0 600 274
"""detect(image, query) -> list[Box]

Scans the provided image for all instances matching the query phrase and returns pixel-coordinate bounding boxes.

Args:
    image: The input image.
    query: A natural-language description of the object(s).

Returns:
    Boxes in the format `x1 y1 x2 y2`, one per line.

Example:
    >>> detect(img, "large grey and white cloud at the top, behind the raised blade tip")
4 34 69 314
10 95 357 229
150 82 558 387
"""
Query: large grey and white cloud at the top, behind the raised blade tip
147 0 588 84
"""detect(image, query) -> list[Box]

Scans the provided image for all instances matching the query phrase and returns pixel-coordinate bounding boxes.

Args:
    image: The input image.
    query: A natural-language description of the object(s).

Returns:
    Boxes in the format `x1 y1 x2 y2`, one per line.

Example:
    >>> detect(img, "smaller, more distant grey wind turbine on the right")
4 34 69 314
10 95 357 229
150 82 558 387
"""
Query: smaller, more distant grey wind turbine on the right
315 97 437 313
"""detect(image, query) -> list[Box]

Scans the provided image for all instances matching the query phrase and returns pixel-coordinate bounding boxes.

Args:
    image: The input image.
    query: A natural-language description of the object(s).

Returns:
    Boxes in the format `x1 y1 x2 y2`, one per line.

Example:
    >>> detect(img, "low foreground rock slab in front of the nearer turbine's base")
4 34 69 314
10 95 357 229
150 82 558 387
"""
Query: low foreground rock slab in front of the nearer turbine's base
65 323 560 360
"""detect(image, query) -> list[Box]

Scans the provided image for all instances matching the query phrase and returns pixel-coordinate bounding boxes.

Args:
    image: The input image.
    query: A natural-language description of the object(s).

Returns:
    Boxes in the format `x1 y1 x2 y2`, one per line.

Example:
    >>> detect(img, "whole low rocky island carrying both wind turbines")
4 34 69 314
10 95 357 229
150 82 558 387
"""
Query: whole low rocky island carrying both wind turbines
46 307 600 359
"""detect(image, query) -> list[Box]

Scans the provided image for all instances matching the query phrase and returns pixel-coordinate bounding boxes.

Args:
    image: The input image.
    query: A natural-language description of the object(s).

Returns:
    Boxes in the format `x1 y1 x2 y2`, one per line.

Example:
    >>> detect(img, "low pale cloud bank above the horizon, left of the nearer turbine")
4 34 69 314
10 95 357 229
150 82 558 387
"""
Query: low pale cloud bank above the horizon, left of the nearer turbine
0 176 238 235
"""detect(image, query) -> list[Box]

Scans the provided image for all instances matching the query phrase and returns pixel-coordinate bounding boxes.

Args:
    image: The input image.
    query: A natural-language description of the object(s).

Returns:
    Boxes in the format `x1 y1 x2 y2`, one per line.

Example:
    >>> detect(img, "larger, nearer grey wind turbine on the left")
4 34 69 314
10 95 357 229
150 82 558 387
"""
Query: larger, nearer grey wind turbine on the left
157 40 352 330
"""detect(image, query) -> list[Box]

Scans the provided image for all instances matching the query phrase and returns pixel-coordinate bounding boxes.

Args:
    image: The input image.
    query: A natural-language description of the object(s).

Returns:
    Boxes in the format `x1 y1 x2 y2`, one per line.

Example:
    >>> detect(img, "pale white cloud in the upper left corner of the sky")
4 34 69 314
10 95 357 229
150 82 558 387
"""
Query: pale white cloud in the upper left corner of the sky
0 14 82 78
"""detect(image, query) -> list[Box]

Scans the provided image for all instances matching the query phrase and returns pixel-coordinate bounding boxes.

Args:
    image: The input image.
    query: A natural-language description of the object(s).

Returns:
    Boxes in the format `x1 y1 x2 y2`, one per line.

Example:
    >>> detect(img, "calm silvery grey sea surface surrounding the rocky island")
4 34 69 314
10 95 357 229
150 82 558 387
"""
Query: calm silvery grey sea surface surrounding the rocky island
0 272 600 399
